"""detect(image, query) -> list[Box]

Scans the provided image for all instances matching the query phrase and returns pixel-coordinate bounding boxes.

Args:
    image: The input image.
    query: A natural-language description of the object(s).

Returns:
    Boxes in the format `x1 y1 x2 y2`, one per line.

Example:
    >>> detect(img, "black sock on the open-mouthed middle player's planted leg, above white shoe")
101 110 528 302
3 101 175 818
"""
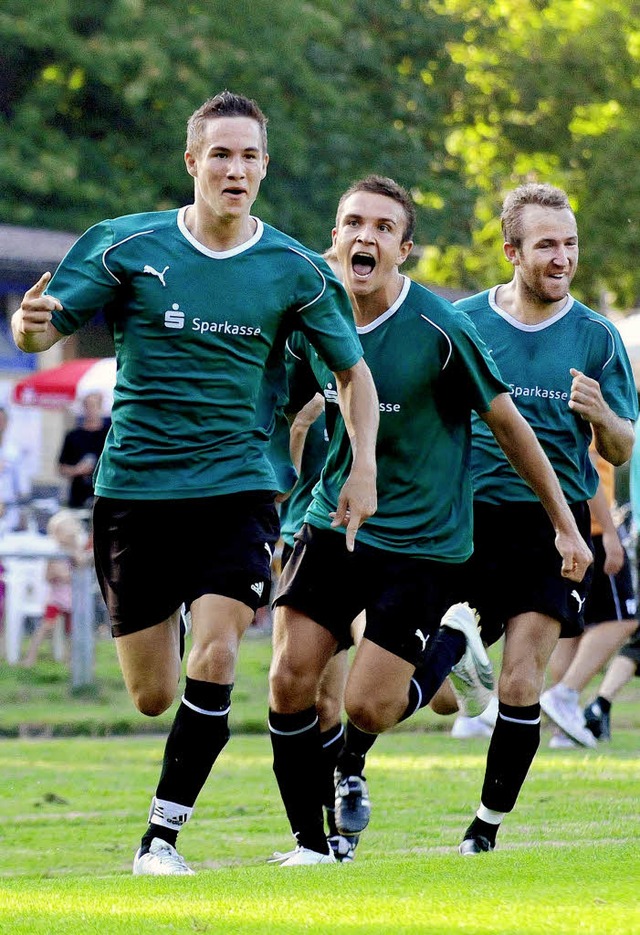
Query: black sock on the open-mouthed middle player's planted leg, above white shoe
269 706 329 854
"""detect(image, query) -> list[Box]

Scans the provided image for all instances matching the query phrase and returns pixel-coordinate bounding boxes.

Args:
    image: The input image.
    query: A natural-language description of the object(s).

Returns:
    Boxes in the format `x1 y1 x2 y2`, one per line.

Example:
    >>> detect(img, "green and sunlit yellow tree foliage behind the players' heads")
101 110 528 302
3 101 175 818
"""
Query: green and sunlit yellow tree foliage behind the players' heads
0 0 640 308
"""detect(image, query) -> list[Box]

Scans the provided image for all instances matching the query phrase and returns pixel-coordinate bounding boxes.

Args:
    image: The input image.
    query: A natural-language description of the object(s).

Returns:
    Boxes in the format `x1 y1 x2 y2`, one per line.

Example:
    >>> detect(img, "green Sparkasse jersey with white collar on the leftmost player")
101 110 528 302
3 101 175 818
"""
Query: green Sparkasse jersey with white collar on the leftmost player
48 208 362 500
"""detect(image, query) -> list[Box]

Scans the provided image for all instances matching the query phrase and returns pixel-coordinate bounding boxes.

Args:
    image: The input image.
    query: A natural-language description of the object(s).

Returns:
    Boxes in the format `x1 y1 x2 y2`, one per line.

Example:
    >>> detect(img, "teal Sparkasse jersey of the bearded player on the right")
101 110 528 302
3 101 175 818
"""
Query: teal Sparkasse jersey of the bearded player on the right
456 286 638 504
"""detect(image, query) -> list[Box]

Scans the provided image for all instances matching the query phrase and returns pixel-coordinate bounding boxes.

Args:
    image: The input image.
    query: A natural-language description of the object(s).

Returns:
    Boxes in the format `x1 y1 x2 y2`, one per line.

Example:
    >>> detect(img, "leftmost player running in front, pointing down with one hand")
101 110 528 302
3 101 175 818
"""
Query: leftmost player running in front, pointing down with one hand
12 91 378 875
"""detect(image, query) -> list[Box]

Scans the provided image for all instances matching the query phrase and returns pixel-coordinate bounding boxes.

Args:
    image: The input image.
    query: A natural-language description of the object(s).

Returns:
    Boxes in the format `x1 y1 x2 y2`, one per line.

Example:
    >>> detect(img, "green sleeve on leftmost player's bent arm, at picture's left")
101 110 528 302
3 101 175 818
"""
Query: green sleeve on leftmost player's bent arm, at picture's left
47 221 121 334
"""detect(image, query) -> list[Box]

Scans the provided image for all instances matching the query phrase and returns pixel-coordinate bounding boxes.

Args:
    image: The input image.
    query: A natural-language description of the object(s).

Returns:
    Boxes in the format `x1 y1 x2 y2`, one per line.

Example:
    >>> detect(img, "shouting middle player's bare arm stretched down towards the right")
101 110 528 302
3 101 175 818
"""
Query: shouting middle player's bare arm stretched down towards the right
480 393 593 581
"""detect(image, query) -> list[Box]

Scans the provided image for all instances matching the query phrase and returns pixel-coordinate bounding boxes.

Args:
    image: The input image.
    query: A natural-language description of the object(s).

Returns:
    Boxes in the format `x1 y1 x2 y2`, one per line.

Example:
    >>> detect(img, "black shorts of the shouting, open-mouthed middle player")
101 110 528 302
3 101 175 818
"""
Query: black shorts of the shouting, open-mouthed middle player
273 524 468 666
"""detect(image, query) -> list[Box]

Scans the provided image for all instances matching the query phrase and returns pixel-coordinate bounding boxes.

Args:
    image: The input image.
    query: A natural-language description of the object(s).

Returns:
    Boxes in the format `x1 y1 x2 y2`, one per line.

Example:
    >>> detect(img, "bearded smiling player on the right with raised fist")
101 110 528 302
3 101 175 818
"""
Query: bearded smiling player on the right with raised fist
456 183 637 856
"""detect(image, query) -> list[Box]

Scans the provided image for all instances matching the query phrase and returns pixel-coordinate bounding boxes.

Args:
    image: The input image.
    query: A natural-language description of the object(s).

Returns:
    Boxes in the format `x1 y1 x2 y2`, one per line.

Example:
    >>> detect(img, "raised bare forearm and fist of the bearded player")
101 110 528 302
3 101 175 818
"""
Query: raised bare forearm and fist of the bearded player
569 367 634 465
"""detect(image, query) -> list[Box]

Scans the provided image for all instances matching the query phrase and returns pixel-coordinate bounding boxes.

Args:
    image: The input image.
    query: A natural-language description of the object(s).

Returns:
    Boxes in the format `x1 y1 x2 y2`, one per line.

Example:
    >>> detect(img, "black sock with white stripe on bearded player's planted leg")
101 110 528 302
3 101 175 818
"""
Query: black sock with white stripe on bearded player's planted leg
482 701 540 812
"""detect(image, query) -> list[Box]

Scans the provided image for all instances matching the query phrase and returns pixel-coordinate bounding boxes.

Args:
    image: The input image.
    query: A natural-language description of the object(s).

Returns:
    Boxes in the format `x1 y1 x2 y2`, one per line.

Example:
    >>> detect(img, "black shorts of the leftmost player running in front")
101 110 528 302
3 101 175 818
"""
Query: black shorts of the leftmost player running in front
93 491 279 636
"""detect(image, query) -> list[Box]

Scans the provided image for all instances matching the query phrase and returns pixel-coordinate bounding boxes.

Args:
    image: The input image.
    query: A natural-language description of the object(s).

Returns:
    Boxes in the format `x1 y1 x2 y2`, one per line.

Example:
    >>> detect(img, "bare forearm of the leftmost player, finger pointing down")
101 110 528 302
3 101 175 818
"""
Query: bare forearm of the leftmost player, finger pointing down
331 358 380 552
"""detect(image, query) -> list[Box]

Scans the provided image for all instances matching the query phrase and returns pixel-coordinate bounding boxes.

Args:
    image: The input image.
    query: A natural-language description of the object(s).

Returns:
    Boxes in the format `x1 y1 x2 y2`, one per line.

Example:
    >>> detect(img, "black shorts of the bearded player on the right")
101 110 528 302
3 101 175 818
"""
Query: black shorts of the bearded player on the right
467 501 591 645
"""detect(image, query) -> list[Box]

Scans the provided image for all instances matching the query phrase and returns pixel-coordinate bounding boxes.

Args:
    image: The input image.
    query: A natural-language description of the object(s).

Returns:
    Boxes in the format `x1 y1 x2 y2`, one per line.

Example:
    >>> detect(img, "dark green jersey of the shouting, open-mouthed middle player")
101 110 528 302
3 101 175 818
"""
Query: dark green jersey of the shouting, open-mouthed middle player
294 277 507 562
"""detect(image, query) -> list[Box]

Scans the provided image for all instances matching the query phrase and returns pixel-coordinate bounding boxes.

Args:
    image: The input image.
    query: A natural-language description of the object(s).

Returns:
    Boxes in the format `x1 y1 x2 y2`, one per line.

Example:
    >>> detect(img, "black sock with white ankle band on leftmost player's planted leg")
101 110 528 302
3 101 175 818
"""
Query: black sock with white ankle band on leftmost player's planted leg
142 676 233 853
